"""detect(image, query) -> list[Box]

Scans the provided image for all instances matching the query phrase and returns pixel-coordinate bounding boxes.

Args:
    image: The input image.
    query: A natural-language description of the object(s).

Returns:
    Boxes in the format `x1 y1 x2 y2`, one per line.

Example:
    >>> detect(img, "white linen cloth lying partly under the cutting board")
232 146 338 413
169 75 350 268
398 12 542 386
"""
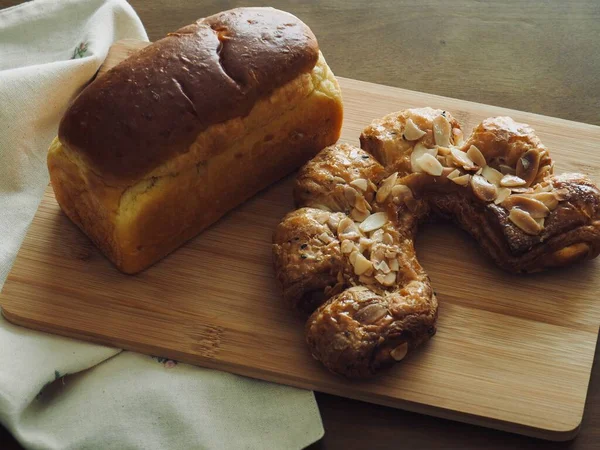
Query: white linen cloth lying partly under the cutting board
0 0 323 449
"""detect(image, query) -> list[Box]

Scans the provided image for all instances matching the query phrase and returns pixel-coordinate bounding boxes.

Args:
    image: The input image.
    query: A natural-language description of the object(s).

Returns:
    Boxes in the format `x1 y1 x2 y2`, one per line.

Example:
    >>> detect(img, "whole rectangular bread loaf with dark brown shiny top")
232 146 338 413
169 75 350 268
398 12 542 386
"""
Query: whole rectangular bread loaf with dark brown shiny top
48 8 342 273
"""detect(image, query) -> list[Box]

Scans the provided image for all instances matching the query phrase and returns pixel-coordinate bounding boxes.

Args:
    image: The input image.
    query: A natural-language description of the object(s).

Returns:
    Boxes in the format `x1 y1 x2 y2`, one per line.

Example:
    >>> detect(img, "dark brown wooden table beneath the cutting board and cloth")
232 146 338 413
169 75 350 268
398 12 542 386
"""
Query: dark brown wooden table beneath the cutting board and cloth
0 0 600 450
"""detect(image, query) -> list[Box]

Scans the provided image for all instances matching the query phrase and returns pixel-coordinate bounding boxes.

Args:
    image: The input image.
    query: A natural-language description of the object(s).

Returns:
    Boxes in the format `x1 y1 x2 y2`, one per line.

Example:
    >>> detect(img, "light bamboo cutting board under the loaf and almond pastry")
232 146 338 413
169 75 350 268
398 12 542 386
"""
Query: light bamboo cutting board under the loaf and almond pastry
0 38 600 440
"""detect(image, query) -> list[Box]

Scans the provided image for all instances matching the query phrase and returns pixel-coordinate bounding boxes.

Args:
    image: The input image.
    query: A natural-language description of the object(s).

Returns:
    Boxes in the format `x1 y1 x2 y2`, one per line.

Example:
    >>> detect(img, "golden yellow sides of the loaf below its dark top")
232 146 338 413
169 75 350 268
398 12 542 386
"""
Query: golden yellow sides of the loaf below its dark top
48 9 343 273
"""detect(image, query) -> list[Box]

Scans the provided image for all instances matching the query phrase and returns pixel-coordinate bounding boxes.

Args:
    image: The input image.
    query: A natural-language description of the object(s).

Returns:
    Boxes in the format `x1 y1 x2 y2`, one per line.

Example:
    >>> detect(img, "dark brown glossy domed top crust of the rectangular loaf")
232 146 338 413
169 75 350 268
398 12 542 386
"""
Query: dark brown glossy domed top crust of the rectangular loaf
58 8 319 181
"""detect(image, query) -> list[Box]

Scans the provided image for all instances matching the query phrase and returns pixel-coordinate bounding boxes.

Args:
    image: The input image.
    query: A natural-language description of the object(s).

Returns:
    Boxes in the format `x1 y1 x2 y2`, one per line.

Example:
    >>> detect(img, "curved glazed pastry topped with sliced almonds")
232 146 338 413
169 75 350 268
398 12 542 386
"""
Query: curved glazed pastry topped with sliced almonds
273 108 600 377
